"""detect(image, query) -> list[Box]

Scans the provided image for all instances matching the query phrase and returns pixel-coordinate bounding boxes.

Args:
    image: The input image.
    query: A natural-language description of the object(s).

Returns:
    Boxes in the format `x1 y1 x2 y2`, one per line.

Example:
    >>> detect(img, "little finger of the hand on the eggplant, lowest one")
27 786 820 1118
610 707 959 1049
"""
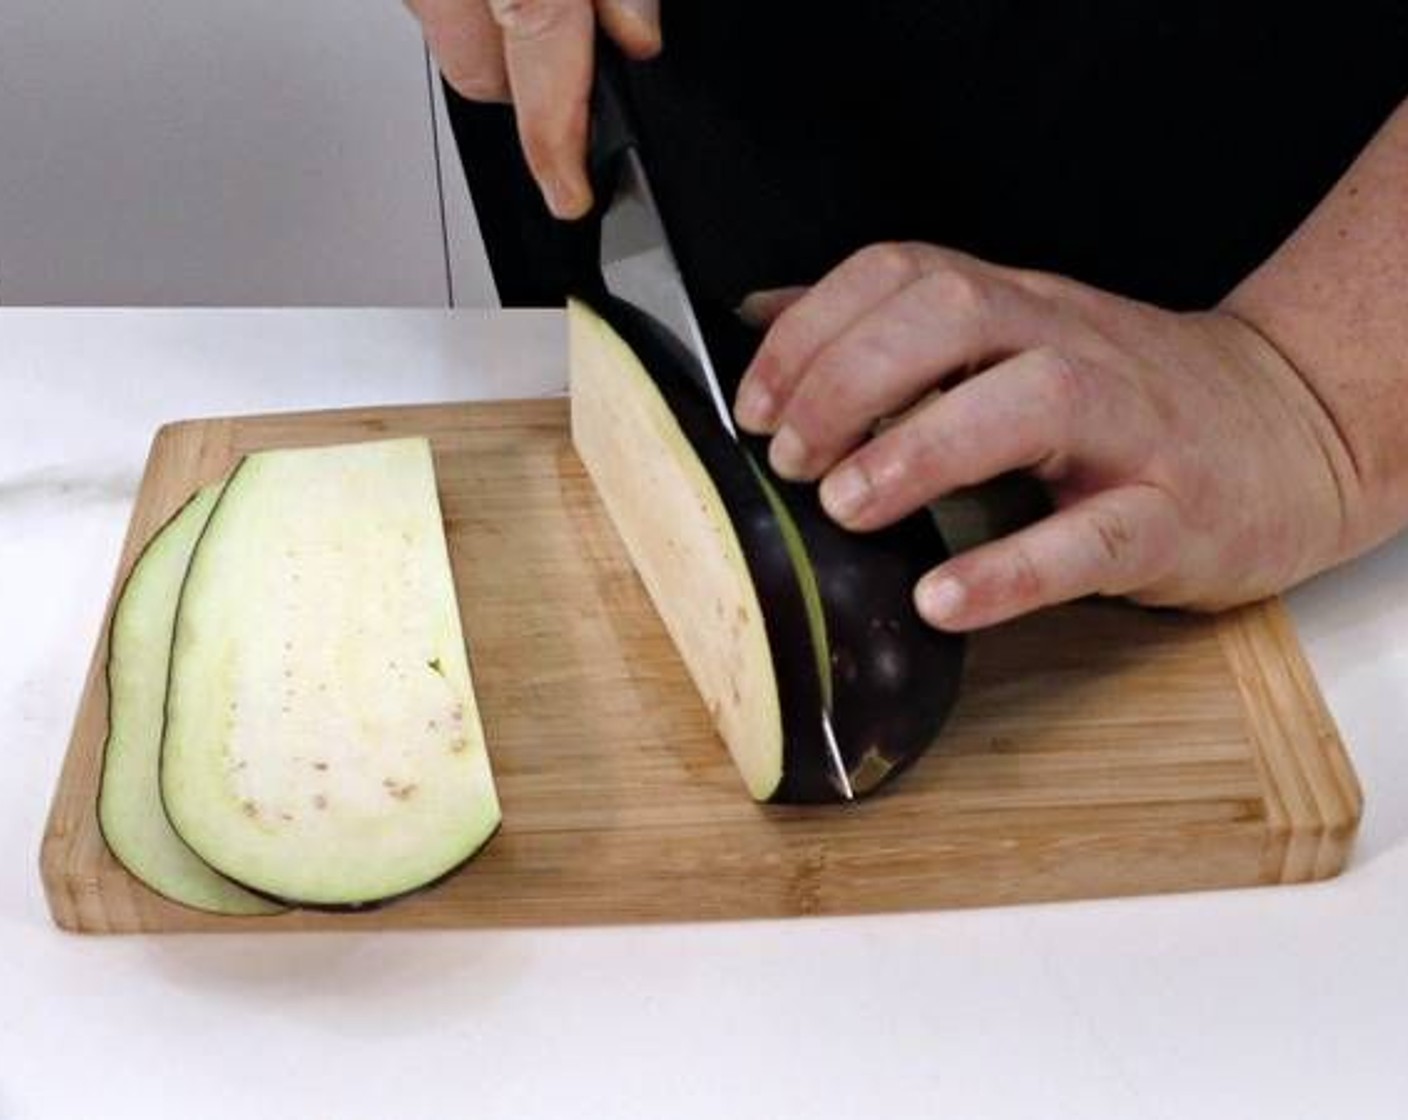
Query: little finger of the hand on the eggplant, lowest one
914 486 1178 631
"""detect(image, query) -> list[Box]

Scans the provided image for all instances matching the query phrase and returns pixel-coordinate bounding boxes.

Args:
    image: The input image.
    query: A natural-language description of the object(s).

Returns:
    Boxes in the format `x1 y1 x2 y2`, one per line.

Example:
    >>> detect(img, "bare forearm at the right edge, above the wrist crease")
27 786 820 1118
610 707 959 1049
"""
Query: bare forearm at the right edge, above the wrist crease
1224 101 1408 559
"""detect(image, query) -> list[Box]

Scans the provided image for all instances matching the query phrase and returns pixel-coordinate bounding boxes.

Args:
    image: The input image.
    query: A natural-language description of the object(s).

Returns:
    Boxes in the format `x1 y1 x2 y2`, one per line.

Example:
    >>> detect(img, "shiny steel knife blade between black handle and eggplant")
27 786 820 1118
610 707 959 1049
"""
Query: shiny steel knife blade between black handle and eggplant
601 148 738 440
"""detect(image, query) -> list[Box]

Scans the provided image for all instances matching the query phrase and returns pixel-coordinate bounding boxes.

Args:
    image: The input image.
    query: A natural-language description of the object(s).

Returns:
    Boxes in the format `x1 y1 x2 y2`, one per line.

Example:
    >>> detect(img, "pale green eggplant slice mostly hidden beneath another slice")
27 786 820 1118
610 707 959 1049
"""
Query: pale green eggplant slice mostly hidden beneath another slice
97 483 282 916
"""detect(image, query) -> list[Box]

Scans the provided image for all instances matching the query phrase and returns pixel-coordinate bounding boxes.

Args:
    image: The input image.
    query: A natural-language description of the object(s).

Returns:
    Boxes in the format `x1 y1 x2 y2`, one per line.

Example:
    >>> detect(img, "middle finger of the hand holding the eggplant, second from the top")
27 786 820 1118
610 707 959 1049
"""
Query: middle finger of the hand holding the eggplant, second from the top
770 266 1060 479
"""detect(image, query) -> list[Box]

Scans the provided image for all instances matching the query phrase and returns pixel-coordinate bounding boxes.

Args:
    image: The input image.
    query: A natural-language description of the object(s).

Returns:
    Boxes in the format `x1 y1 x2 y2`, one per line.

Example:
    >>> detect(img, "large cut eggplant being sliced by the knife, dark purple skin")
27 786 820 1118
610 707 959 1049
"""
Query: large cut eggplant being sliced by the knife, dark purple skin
569 297 964 803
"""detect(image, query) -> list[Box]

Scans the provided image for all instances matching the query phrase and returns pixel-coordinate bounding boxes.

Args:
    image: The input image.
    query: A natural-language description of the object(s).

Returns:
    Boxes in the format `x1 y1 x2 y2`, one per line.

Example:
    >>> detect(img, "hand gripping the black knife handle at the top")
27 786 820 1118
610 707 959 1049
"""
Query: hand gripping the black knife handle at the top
406 0 660 218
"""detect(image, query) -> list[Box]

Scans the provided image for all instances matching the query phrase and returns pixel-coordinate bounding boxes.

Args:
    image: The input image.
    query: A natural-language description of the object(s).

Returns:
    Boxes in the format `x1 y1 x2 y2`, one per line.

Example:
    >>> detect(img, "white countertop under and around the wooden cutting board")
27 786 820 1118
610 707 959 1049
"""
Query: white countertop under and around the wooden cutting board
0 310 1408 1120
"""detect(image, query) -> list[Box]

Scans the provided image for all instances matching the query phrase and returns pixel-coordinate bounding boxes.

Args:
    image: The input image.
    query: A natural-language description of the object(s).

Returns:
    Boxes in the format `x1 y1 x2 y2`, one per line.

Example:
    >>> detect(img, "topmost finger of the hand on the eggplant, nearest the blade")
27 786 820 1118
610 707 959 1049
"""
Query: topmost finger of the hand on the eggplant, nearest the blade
735 244 942 433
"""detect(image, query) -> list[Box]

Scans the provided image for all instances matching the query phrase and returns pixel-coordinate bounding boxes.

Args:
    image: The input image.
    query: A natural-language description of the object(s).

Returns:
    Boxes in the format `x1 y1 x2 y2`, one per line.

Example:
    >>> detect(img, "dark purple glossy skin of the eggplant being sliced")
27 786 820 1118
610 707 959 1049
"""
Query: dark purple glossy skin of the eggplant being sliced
590 290 964 804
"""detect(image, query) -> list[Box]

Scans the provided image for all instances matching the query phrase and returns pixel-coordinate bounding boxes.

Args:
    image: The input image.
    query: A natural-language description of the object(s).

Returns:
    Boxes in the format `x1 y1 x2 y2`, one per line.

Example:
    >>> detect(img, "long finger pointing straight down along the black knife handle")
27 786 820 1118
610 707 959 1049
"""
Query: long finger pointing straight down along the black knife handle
489 0 596 218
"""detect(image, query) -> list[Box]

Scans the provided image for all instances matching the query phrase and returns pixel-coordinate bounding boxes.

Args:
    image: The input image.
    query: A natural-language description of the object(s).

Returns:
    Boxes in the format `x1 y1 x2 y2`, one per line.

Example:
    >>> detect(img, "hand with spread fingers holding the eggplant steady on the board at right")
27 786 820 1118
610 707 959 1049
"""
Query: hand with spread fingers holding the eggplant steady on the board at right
736 245 1350 630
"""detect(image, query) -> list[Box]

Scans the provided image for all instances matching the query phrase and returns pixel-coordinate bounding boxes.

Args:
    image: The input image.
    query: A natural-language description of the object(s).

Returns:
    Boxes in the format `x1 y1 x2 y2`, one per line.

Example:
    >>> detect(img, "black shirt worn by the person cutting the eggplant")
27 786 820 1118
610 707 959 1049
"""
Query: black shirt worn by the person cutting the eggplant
452 0 1408 307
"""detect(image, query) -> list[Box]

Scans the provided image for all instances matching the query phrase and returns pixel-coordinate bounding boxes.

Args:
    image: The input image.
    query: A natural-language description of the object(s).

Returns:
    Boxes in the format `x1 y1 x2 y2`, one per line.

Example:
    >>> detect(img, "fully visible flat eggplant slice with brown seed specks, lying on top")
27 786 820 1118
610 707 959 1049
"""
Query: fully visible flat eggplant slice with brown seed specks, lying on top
161 440 500 909
